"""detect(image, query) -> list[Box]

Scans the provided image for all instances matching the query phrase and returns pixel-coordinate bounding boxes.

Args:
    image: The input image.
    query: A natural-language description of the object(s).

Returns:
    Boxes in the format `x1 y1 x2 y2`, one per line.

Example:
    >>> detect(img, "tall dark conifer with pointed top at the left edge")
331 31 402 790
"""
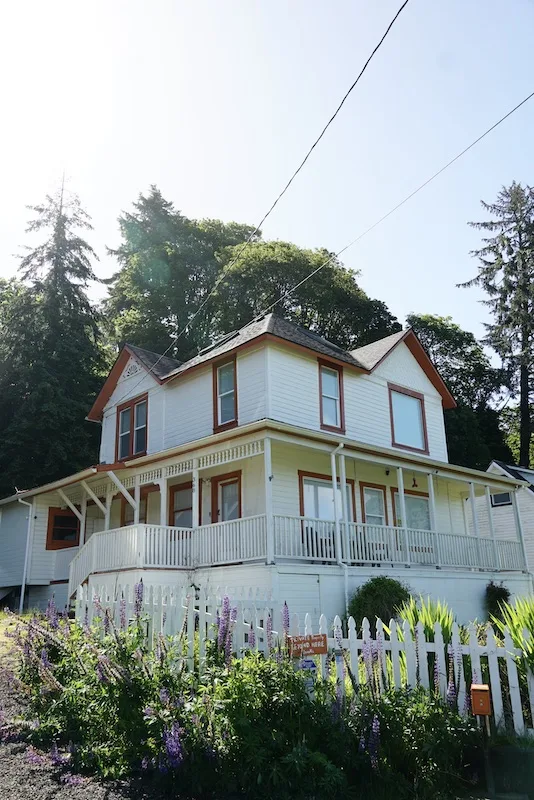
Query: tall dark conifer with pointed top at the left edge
0 189 105 495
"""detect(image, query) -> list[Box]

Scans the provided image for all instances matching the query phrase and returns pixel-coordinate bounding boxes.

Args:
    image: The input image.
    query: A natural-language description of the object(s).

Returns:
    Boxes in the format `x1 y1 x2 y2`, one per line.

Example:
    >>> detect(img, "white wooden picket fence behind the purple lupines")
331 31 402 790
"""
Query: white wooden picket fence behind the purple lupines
75 584 534 735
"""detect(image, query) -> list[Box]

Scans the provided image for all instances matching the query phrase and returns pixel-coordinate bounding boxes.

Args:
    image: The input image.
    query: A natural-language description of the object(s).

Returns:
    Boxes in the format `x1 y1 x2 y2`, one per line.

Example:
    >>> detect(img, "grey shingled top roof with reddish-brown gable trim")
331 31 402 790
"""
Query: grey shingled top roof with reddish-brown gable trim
87 313 456 422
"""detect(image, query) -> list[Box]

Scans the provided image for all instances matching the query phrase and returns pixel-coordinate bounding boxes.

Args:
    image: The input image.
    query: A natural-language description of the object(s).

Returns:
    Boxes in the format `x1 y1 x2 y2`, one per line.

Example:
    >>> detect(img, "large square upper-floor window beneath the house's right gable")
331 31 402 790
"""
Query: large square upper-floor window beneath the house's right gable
388 384 428 453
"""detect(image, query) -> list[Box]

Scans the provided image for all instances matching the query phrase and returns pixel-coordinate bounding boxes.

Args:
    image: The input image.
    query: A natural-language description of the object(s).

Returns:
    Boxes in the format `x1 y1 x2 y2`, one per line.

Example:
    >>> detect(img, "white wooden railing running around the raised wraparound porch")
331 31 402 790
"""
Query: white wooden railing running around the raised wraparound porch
69 514 524 594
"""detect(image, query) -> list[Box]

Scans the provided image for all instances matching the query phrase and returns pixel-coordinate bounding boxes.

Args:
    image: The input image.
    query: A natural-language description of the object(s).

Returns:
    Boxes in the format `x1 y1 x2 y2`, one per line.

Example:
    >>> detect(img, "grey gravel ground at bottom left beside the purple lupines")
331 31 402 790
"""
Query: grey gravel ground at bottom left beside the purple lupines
0 618 191 800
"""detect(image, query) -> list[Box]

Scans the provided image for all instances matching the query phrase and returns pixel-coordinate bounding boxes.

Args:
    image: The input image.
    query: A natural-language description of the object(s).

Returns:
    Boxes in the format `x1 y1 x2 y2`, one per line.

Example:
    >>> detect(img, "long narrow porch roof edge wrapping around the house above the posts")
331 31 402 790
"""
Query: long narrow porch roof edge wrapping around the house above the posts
0 419 529 505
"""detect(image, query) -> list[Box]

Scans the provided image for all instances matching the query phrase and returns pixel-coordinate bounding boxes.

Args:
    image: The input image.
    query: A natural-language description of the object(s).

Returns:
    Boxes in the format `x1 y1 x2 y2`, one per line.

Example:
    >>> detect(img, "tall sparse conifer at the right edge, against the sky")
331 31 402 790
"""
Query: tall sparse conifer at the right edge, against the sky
460 182 534 467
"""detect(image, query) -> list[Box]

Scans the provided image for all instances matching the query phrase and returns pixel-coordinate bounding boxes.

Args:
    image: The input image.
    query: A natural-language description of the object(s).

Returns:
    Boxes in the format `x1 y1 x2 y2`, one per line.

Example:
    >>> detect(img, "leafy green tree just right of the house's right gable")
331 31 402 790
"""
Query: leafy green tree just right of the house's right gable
406 314 512 469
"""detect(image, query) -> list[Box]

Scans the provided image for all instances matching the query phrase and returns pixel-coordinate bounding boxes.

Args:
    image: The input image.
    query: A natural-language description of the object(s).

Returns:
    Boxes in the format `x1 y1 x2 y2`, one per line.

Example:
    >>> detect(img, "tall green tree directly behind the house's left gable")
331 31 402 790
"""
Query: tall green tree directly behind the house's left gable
105 186 253 360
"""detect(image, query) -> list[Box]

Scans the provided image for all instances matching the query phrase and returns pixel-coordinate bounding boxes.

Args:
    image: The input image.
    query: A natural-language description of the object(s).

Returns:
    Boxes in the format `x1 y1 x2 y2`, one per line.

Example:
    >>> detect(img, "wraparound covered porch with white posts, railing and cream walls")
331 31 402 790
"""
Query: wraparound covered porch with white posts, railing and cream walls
61 432 526 595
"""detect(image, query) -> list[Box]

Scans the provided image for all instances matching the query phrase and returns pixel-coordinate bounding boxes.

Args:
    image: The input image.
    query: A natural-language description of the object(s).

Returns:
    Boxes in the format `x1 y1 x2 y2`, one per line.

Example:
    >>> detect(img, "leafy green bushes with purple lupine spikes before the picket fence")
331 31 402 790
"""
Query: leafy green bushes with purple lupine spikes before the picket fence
7 606 482 800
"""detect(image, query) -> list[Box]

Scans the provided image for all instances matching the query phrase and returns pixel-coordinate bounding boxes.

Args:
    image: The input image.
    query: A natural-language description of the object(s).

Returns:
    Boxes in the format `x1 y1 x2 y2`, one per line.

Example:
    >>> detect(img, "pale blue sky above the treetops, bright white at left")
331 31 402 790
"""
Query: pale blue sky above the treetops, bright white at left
0 0 534 336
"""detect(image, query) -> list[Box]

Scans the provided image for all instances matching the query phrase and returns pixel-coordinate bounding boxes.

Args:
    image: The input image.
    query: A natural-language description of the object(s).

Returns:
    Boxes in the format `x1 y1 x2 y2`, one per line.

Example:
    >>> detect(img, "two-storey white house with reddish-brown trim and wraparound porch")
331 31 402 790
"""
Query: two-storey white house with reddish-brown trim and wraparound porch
0 314 530 620
